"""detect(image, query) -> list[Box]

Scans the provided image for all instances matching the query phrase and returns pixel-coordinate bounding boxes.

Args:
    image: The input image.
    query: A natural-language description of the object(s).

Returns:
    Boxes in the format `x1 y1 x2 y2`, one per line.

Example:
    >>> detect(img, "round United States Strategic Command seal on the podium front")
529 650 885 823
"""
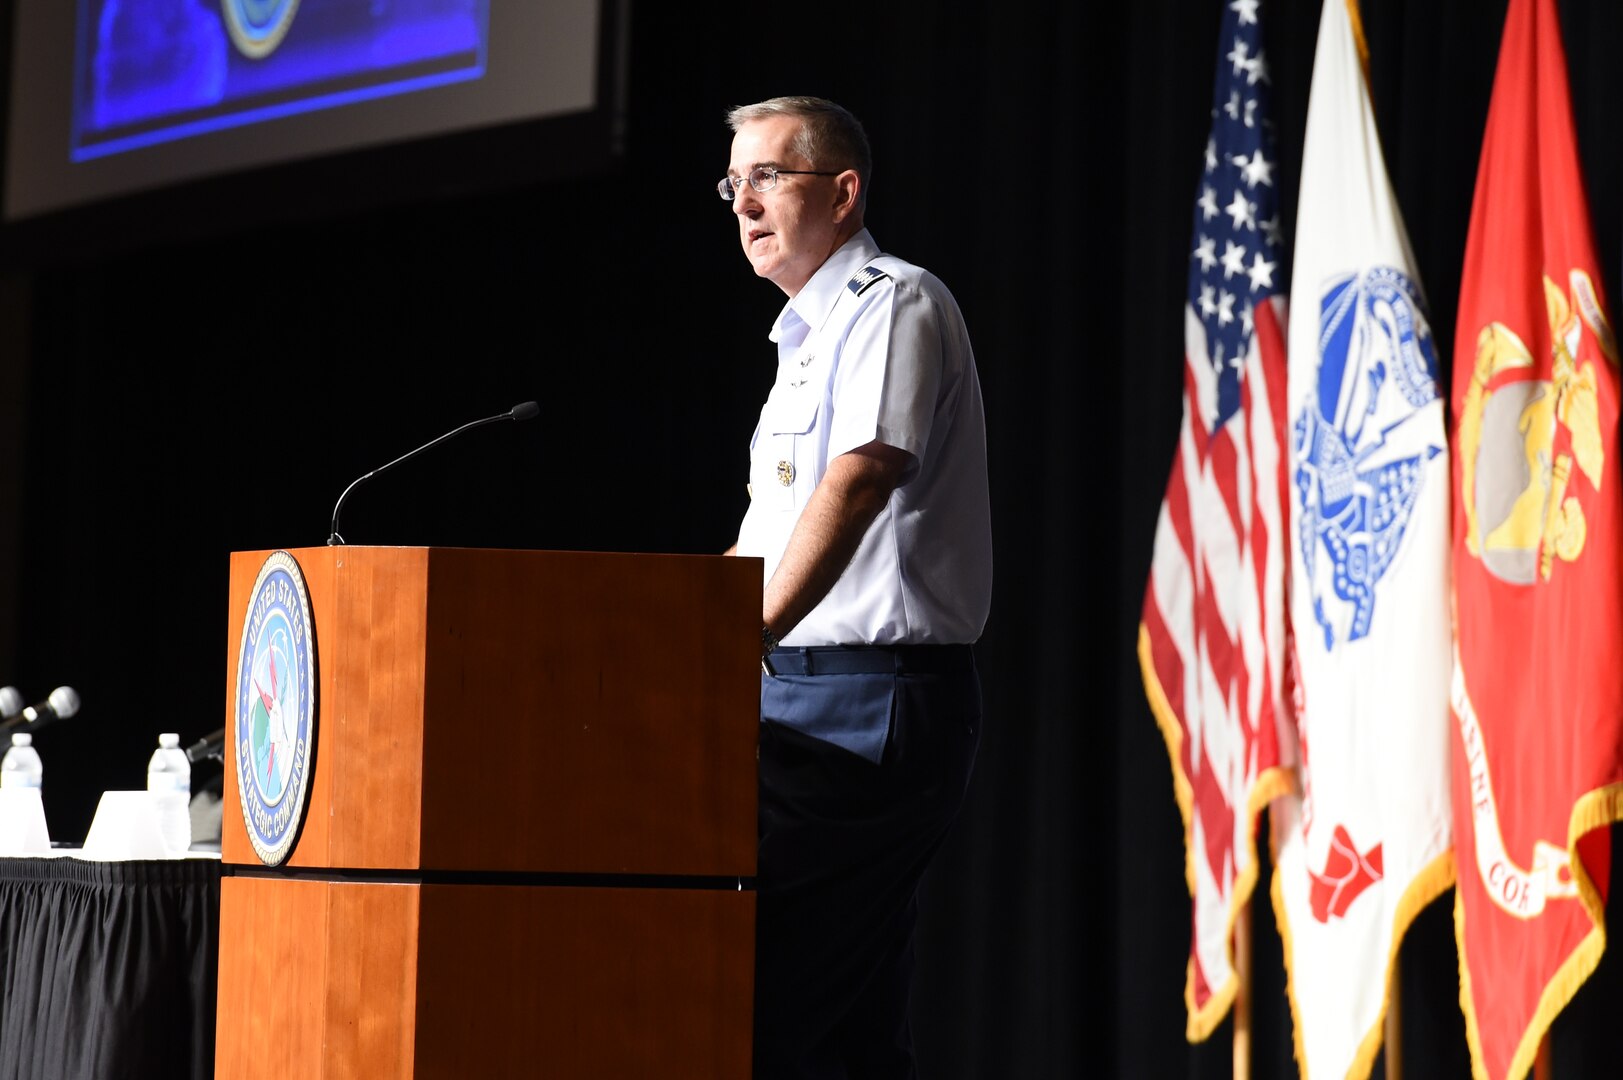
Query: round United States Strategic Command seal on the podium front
234 551 315 866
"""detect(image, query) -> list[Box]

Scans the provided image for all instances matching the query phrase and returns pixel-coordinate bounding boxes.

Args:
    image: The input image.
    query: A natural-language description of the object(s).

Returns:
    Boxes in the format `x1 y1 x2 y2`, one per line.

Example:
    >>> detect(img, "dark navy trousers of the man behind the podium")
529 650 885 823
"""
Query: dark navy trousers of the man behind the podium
755 648 980 1080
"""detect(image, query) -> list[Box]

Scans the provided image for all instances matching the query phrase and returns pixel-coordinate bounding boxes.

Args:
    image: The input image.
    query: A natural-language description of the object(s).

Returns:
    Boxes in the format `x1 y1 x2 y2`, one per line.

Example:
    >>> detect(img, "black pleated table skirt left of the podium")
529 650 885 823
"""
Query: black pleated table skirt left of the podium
0 858 219 1080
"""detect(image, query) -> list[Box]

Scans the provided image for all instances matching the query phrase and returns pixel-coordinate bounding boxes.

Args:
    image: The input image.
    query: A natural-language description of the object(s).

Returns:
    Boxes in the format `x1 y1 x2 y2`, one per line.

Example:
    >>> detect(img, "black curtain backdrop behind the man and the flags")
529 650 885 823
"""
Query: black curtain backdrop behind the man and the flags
0 0 1623 1078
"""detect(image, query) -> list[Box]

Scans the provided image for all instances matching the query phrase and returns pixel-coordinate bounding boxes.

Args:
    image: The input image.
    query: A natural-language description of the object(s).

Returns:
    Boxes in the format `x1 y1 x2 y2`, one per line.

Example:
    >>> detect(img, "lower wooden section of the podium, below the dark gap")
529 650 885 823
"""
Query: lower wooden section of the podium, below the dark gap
214 877 755 1080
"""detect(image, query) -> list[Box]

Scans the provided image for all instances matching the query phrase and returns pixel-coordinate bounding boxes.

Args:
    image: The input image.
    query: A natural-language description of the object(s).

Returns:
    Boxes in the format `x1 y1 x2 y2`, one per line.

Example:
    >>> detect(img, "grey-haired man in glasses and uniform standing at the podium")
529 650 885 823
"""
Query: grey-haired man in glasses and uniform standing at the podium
719 97 992 1080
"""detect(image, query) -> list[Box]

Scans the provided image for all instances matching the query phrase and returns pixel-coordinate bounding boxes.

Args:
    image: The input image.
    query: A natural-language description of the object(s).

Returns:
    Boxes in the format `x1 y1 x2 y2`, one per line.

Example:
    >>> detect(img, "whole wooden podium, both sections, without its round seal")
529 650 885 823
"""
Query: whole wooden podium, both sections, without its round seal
216 547 761 1080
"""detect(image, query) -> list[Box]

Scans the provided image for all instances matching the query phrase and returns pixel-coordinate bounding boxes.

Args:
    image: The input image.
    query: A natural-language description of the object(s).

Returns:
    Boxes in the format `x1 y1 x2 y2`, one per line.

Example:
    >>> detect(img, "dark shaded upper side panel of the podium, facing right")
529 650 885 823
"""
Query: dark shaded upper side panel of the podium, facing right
422 549 761 877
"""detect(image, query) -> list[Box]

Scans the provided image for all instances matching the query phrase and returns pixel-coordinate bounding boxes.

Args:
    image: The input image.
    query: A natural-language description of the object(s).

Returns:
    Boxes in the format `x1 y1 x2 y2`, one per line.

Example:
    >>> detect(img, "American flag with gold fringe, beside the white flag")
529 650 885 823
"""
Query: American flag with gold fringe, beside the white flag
1139 0 1290 1039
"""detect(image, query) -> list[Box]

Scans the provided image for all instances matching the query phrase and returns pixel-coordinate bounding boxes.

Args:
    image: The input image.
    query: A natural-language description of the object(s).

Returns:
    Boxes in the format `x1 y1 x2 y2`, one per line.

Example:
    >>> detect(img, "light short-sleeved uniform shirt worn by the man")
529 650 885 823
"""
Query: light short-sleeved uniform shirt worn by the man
738 229 992 645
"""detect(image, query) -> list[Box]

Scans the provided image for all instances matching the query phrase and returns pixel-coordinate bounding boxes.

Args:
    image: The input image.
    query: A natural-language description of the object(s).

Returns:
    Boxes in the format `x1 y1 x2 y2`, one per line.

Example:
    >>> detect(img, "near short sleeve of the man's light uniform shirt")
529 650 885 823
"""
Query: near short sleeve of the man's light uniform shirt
828 279 943 464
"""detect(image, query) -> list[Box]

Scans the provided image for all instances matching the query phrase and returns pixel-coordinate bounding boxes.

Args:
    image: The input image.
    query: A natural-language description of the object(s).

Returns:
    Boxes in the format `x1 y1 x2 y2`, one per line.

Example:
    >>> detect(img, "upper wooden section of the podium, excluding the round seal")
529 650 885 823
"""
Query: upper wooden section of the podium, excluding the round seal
222 547 761 877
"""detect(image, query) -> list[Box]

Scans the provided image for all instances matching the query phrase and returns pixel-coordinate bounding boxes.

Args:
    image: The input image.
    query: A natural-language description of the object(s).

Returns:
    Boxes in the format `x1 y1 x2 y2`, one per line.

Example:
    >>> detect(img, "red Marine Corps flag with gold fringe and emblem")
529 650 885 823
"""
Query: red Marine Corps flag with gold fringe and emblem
1453 0 1623 1080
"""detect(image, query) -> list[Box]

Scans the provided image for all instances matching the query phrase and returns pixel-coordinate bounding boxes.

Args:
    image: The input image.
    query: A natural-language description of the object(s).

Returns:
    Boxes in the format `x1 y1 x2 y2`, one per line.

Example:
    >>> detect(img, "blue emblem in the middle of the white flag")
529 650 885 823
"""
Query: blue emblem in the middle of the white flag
1292 266 1443 650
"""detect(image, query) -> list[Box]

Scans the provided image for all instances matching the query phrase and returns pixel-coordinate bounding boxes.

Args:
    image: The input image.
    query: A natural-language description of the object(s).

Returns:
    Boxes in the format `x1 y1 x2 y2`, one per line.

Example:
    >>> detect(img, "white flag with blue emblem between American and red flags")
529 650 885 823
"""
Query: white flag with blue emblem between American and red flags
1274 0 1453 1078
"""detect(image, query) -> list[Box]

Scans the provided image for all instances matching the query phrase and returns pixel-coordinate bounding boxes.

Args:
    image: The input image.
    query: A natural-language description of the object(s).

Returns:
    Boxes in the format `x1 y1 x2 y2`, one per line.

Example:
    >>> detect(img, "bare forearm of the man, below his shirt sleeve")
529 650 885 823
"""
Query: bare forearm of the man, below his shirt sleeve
761 442 912 637
